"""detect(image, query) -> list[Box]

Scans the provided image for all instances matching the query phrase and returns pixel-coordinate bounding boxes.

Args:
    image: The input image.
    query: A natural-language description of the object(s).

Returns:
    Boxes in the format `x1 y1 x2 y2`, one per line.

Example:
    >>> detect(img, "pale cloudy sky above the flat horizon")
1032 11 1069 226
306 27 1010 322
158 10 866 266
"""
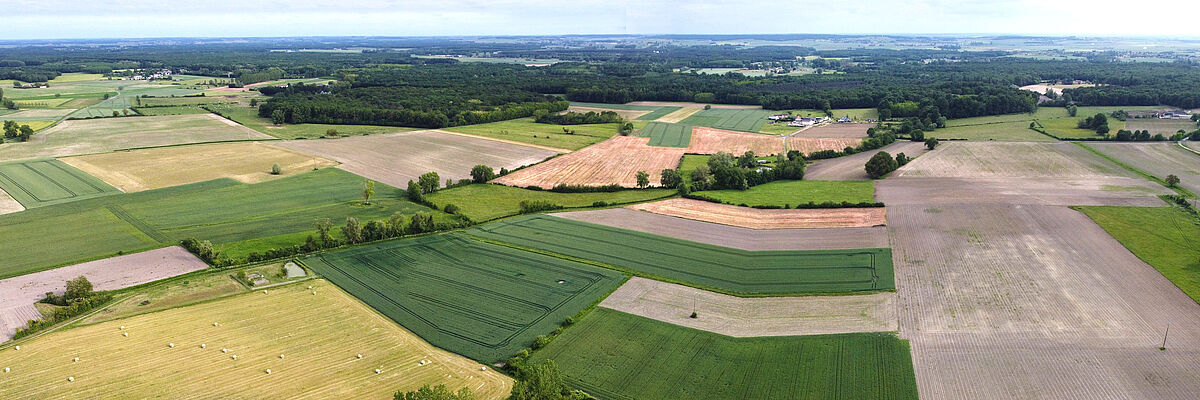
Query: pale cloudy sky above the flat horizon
7 0 1200 40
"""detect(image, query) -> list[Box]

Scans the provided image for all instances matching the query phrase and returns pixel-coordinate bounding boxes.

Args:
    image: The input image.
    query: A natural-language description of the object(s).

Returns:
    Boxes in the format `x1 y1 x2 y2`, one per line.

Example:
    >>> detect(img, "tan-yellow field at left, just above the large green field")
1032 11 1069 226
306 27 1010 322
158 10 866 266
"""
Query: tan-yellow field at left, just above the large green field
60 142 336 192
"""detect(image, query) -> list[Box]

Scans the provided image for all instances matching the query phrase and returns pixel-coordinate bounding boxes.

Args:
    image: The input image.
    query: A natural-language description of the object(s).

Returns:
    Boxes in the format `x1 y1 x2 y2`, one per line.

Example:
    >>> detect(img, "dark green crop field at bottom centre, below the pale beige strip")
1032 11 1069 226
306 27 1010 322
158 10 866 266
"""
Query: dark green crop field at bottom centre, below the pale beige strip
530 308 917 399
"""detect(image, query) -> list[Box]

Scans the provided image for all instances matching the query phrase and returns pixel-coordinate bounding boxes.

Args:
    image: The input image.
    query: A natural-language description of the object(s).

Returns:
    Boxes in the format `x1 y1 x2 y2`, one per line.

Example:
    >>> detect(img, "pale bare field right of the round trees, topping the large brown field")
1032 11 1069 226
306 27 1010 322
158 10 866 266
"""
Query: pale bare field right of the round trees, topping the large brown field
893 142 1135 180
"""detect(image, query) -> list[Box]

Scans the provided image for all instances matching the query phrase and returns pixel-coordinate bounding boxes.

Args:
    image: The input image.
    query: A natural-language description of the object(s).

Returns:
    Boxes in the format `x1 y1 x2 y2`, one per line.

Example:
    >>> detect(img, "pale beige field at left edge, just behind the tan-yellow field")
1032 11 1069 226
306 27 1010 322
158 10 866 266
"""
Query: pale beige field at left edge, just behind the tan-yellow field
0 114 271 160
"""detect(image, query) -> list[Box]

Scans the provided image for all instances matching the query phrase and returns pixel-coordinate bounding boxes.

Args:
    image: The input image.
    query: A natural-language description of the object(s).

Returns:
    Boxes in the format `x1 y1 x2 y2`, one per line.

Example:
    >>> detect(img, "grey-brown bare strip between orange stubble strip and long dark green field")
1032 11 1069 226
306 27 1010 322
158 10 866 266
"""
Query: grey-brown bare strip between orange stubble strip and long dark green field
551 208 888 250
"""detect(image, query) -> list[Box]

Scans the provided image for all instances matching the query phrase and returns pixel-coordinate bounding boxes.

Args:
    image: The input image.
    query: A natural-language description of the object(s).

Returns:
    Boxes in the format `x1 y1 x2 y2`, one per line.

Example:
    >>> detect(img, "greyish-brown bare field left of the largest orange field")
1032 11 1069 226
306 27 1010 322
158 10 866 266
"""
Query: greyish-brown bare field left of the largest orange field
280 131 556 187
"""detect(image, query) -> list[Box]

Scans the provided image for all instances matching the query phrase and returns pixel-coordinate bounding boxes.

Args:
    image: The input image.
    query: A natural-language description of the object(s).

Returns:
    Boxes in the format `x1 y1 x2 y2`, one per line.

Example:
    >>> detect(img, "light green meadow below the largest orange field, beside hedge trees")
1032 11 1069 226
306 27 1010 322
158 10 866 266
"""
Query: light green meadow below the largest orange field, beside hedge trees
425 185 676 222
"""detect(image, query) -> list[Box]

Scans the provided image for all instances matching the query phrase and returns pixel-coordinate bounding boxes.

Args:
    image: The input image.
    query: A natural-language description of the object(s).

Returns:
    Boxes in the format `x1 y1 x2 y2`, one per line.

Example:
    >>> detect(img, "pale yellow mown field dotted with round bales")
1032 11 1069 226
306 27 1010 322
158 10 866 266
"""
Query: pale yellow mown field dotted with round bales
0 280 512 399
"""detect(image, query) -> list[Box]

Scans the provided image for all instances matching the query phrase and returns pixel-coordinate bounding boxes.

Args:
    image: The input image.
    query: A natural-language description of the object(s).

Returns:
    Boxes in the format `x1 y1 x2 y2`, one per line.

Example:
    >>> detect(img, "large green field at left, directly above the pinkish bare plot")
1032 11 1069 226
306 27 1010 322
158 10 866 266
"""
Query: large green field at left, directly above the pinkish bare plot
0 168 445 279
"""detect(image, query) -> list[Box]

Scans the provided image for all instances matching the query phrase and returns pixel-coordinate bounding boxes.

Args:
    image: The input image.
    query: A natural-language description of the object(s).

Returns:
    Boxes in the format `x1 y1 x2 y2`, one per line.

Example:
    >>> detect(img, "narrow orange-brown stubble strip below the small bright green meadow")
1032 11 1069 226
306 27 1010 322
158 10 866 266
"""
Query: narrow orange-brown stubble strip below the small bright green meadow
629 198 887 229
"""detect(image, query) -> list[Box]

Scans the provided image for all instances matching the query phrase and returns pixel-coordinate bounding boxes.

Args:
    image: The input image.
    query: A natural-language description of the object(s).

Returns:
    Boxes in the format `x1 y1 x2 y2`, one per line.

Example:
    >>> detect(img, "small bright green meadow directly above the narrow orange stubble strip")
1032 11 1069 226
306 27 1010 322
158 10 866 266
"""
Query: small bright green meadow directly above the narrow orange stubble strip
696 180 875 207
